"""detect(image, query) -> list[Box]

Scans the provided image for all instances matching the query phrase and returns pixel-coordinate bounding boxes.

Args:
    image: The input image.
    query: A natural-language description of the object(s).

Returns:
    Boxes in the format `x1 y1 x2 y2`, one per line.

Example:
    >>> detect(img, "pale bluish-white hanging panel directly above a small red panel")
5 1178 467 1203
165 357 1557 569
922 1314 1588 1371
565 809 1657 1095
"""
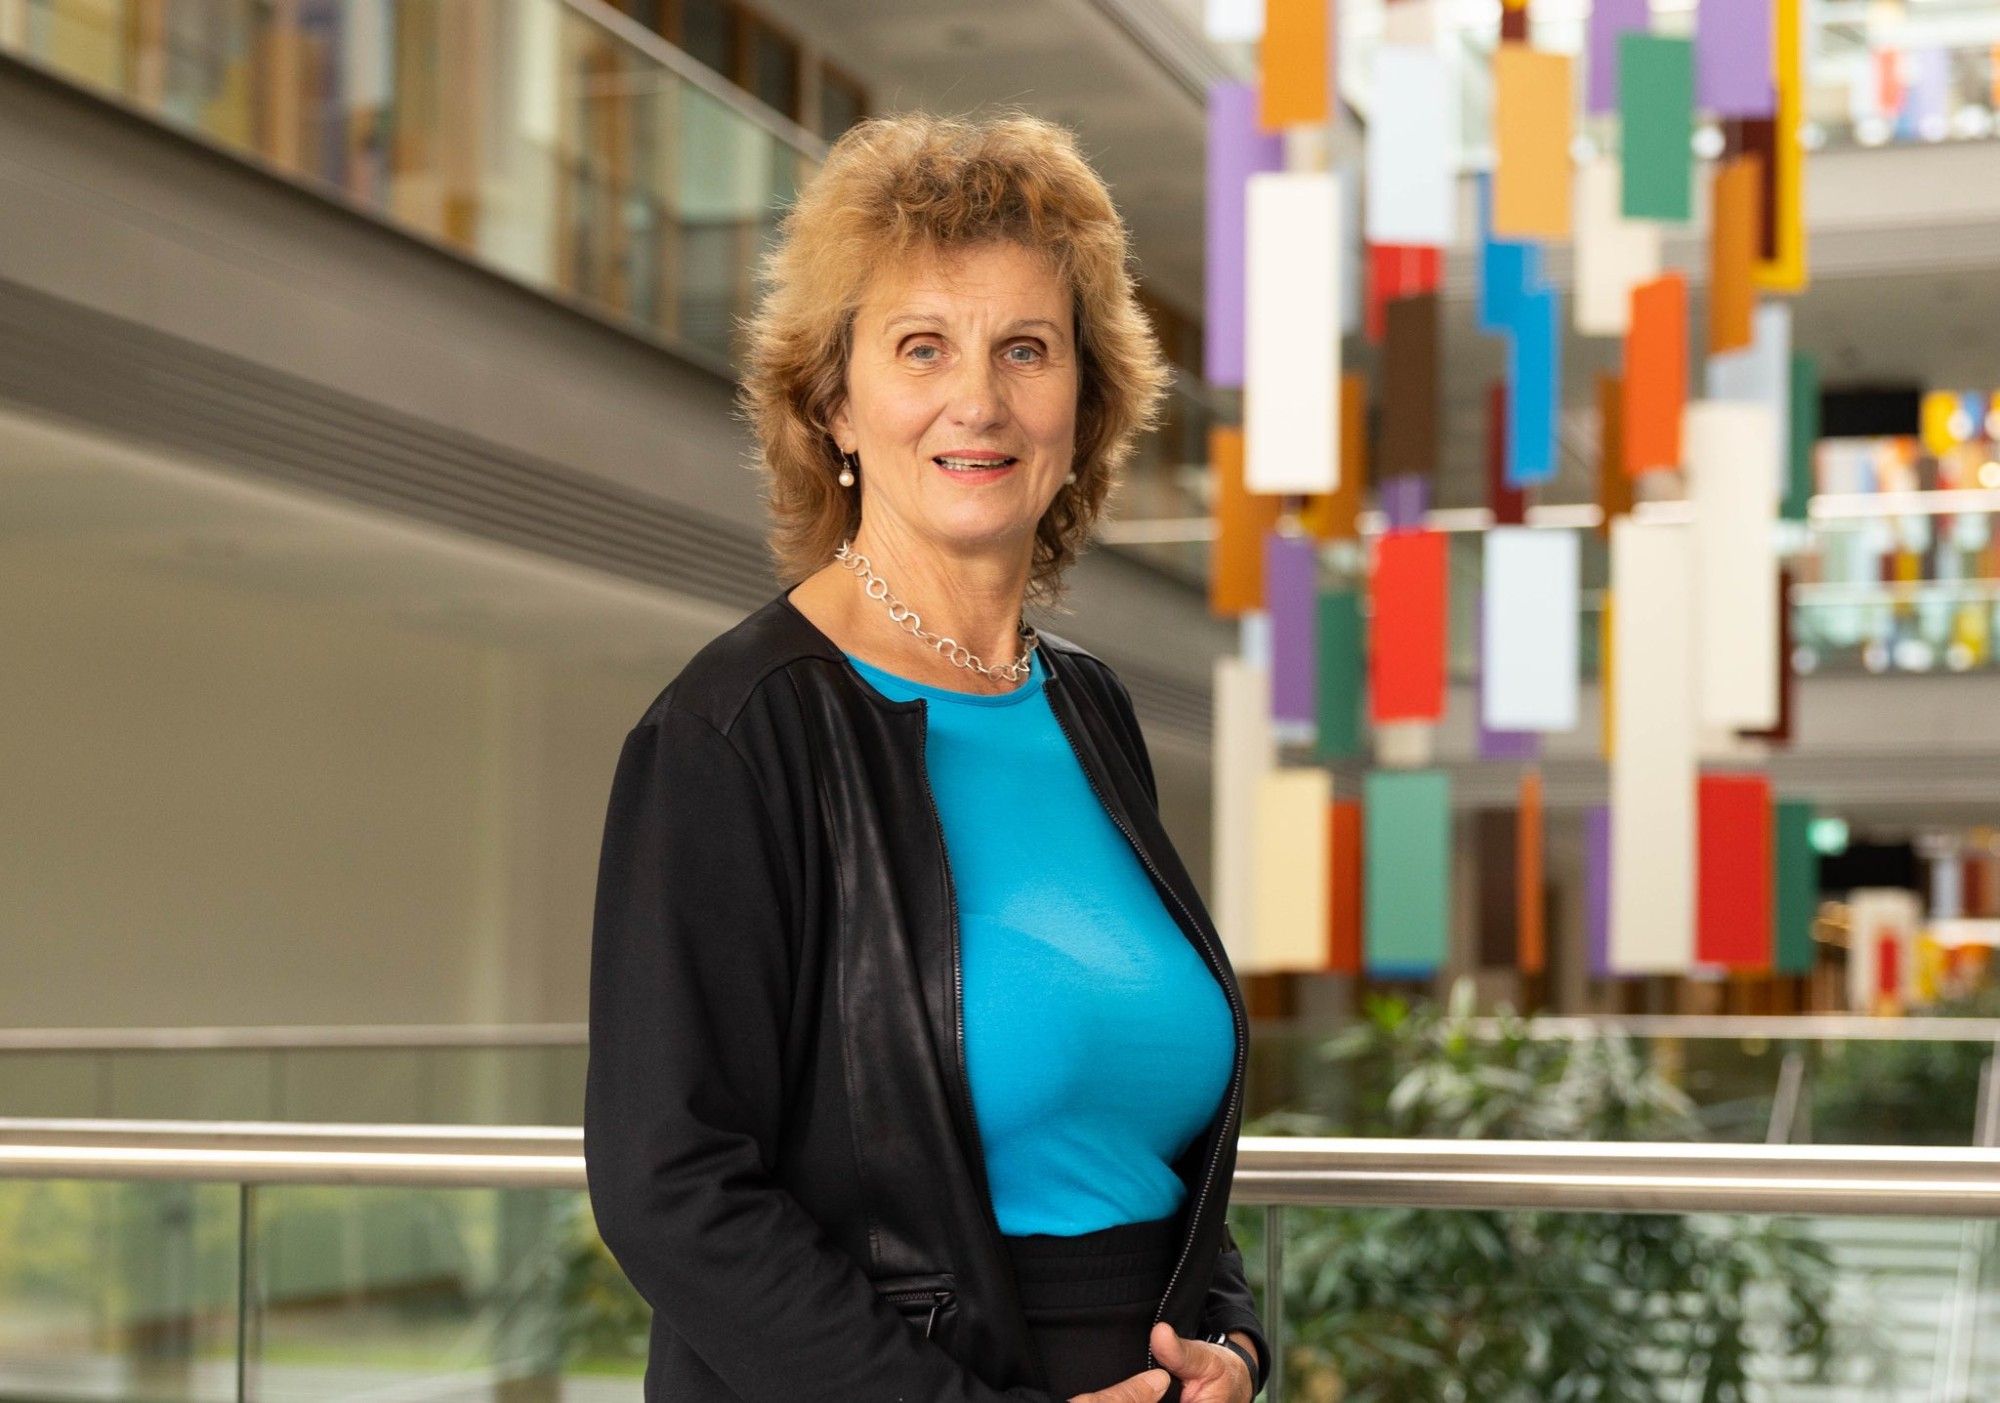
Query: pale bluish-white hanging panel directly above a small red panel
1368 44 1458 246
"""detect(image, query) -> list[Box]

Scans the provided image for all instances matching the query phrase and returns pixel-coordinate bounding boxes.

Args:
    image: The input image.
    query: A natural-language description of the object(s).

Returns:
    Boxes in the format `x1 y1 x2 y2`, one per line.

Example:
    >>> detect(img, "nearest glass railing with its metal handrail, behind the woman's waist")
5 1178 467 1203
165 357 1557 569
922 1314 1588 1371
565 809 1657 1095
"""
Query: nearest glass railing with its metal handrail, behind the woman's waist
0 1121 2000 1403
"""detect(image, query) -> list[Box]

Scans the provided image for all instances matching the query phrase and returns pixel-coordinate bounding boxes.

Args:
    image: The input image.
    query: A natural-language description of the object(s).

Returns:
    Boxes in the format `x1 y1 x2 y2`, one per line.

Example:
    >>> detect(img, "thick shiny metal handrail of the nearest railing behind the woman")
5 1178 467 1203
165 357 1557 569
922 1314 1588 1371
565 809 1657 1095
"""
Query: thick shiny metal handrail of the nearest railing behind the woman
11 1119 2000 1217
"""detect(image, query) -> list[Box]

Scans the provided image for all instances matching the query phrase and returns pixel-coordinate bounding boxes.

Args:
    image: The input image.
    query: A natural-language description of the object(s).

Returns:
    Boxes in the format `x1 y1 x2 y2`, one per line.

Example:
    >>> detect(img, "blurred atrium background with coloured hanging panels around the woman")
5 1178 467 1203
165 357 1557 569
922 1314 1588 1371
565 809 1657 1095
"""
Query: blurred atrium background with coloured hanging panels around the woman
11 0 2000 1401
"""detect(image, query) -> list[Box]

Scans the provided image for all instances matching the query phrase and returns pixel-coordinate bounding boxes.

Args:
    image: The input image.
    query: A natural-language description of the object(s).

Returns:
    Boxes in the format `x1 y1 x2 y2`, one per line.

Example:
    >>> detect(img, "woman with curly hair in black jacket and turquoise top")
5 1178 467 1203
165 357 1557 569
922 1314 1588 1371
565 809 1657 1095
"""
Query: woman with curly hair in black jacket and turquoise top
584 116 1268 1403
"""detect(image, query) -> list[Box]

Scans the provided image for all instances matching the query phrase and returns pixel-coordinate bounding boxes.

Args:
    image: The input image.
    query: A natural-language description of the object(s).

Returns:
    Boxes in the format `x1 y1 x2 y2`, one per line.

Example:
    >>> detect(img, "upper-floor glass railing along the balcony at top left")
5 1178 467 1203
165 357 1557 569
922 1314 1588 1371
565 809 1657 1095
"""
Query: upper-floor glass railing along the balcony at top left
0 0 826 370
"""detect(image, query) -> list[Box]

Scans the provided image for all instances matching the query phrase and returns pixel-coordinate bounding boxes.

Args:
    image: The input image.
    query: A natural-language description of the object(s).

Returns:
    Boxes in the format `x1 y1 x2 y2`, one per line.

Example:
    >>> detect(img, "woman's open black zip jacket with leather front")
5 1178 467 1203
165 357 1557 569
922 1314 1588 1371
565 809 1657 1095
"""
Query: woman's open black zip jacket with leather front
584 594 1270 1403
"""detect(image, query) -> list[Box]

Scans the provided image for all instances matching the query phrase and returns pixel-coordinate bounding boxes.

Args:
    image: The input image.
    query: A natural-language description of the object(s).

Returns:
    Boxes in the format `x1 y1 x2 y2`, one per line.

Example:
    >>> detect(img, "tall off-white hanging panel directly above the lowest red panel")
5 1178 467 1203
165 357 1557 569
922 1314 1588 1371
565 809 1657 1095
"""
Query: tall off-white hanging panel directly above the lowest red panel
1688 400 1778 729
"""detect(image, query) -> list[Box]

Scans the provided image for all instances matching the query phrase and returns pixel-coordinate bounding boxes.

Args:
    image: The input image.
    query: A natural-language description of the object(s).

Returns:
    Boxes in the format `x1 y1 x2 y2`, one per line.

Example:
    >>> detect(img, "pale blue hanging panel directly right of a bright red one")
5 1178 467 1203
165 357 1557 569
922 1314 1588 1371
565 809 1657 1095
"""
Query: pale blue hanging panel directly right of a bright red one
1480 526 1580 731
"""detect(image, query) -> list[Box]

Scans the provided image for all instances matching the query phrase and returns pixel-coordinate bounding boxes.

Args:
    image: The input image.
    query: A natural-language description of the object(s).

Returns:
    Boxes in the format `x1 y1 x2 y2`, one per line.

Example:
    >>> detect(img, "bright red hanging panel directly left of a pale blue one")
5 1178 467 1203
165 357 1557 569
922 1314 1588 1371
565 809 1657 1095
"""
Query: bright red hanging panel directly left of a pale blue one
1368 532 1446 721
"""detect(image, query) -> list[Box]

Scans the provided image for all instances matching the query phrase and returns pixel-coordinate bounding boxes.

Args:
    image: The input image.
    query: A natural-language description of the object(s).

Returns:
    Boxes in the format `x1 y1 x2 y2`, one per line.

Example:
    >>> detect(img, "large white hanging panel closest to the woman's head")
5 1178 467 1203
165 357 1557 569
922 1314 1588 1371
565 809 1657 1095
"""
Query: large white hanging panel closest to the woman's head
1244 170 1340 494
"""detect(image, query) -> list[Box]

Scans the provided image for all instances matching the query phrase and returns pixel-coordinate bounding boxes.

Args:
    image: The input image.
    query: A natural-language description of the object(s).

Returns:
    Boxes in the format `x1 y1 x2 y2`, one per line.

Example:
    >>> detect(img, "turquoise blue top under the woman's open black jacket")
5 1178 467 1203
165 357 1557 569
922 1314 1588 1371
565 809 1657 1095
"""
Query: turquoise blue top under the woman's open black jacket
848 650 1236 1235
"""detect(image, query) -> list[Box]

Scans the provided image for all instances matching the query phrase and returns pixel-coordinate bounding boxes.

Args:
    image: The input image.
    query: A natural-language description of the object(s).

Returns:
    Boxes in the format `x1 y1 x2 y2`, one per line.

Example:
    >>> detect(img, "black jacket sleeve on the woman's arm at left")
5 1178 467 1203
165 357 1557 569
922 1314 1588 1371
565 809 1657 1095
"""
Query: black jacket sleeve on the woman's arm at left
584 707 1056 1403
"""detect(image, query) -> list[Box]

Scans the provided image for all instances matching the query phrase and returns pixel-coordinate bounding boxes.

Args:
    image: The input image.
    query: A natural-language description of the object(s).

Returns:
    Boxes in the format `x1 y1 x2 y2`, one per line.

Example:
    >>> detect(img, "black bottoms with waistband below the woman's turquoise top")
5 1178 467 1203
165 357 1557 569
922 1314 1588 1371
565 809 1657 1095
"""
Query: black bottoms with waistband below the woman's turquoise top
1004 1213 1182 1403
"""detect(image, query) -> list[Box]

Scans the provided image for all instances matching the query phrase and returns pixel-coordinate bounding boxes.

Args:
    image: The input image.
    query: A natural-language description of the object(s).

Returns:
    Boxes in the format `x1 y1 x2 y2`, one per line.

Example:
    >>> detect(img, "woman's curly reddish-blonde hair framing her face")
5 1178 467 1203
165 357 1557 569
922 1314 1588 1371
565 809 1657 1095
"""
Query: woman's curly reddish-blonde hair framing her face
738 110 1174 606
